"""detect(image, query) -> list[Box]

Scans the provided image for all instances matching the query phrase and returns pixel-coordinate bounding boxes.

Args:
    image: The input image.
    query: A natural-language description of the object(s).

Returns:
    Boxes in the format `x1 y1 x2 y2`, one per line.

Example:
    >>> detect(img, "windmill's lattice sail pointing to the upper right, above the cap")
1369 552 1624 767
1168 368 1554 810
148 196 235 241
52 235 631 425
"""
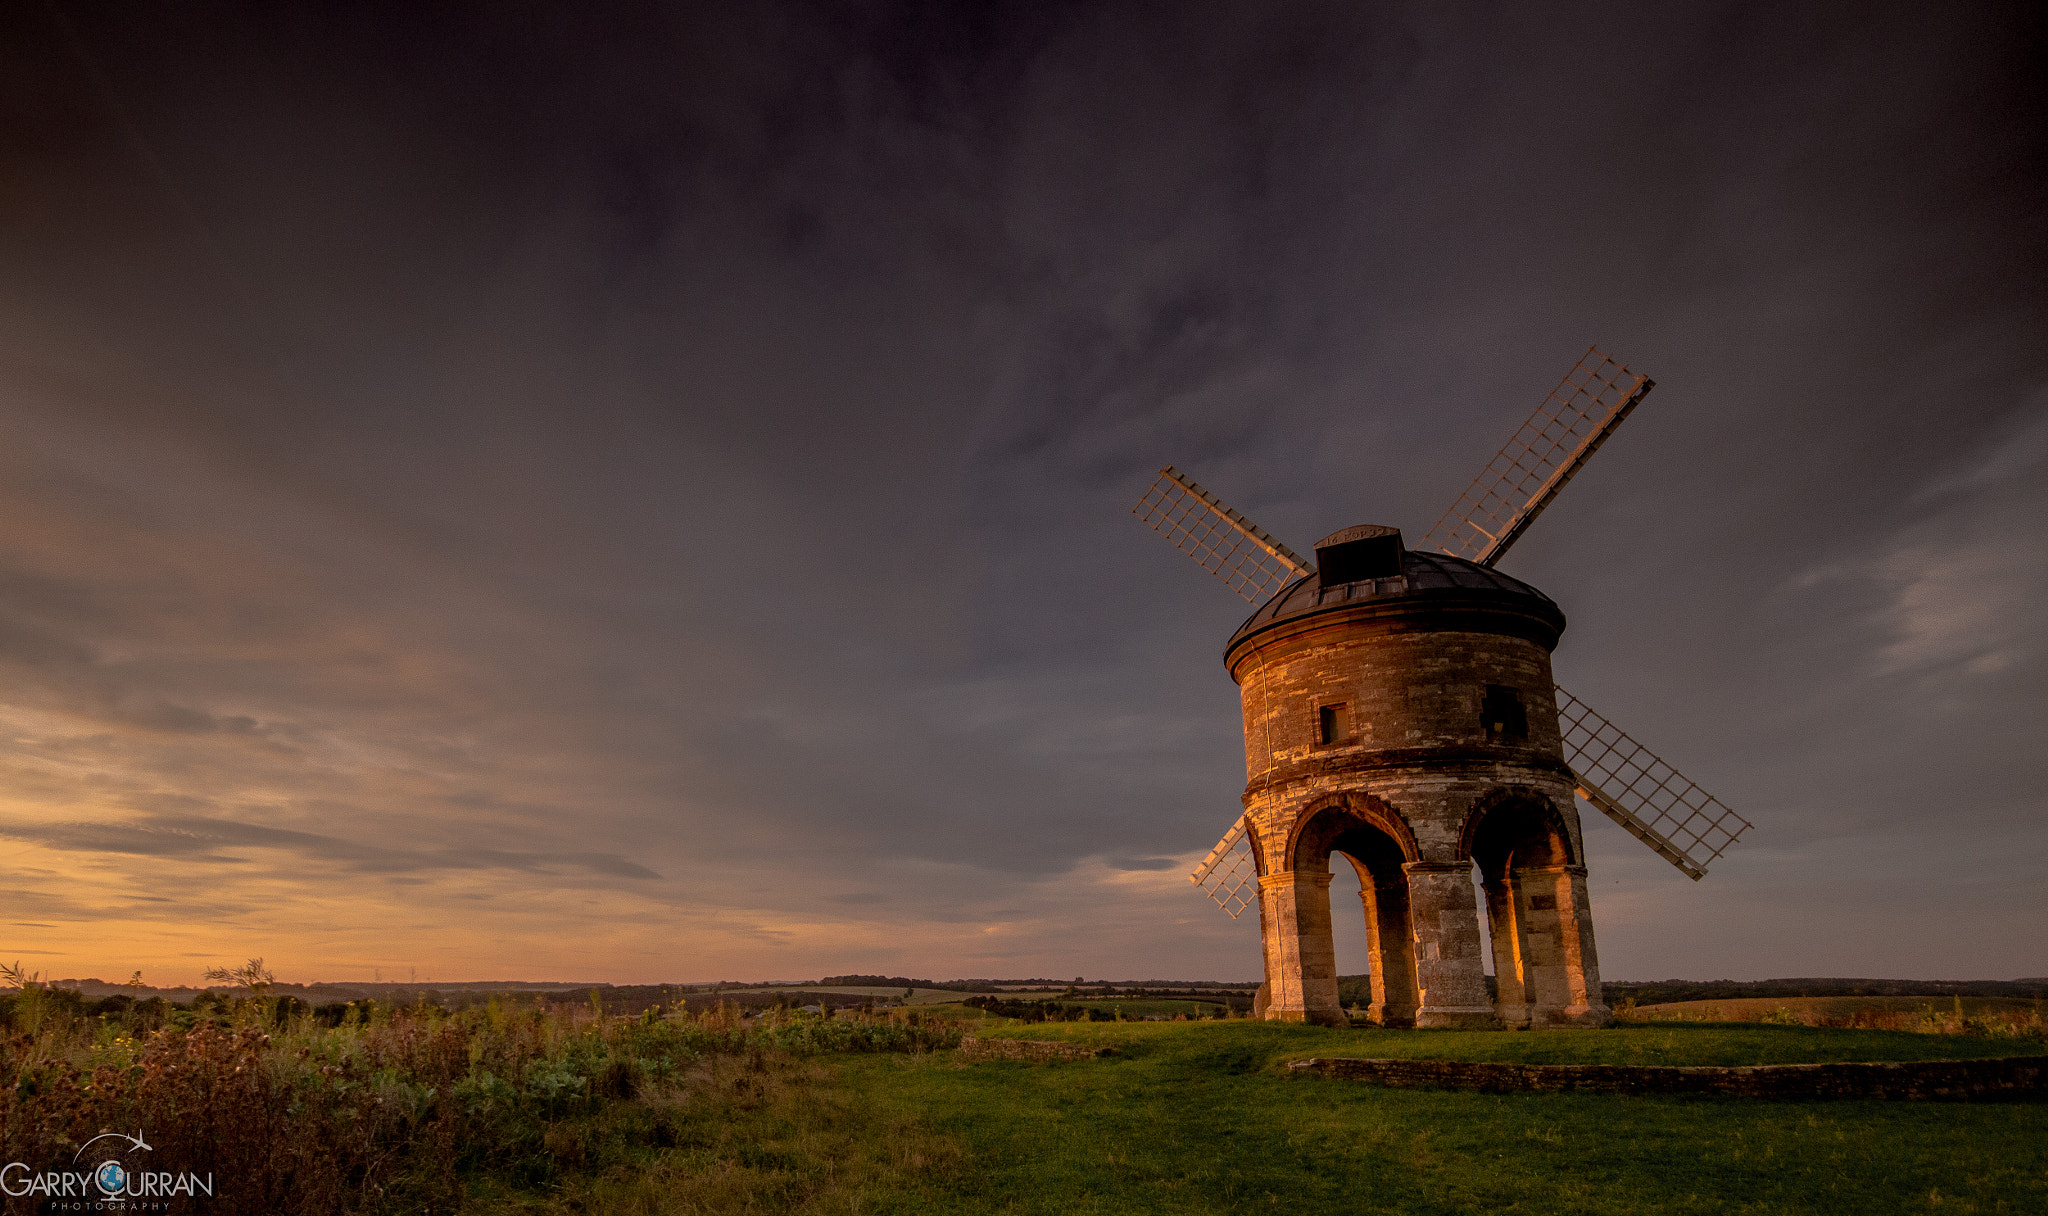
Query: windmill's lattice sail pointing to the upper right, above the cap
1423 346 1657 565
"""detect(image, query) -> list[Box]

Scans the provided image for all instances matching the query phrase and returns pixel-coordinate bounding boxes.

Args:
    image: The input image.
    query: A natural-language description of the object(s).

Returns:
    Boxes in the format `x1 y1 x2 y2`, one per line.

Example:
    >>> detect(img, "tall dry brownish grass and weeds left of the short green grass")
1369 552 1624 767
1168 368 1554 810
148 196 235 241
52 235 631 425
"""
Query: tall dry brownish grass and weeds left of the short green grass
0 987 958 1214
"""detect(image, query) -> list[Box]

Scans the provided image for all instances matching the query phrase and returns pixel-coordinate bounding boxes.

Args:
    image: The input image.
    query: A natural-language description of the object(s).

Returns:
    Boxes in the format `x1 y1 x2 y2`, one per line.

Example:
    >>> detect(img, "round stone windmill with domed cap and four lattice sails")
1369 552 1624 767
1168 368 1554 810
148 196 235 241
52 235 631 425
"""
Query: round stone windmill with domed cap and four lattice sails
1135 350 1749 1028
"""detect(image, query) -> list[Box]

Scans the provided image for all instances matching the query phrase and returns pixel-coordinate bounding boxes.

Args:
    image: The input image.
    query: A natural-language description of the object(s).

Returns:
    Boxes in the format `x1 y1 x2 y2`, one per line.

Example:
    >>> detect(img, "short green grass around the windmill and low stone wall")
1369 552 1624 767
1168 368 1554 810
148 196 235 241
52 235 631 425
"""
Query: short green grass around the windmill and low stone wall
836 1022 2048 1216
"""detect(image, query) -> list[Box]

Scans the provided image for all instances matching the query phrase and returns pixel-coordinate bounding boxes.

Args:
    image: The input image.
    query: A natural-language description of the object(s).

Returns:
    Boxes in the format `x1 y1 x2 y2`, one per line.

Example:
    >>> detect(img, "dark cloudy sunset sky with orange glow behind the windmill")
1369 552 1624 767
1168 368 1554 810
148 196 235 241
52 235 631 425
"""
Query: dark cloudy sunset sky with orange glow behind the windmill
0 0 2048 983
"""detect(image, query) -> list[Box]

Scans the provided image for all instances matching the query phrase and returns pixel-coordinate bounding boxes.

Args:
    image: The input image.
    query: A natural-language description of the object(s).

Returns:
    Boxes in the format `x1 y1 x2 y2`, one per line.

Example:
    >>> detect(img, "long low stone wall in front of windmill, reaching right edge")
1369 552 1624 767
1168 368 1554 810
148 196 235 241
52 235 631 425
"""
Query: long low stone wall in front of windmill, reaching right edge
1288 1056 2048 1101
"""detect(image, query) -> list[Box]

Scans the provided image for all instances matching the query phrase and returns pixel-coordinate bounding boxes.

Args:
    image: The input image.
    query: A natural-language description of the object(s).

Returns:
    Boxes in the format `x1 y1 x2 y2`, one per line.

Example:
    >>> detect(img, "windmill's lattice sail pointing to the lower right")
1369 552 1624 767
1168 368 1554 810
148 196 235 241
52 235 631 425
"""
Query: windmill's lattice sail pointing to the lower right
1556 688 1753 882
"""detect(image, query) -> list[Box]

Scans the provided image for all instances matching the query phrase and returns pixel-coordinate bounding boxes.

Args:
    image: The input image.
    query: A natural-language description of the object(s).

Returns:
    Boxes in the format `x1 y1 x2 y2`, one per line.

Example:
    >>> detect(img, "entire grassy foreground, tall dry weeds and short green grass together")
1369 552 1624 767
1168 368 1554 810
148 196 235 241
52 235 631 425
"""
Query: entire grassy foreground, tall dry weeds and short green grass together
0 991 2048 1216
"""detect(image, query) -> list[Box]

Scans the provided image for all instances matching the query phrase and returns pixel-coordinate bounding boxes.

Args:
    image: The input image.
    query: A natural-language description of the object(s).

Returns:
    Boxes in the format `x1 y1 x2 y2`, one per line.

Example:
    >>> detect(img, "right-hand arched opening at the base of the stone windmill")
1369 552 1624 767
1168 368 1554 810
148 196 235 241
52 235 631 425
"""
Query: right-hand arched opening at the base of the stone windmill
1460 788 1608 1030
